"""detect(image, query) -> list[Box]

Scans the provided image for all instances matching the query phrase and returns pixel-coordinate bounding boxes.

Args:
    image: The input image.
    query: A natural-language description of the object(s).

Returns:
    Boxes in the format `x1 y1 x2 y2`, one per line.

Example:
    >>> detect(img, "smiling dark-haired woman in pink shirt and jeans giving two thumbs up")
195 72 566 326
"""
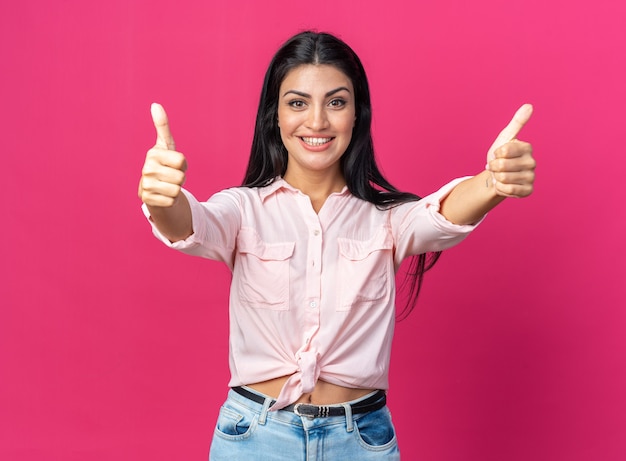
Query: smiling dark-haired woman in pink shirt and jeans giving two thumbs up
139 32 535 461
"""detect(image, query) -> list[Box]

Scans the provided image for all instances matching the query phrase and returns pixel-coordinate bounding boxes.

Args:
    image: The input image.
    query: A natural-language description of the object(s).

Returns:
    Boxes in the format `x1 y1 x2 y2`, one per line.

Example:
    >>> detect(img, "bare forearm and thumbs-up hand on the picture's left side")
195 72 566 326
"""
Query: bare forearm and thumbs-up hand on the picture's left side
138 104 193 242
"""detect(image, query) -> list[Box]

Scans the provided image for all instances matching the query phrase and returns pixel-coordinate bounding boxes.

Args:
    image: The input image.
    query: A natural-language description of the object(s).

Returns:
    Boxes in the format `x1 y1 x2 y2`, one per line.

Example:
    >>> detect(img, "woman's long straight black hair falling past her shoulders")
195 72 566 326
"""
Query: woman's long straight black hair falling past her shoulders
243 31 441 318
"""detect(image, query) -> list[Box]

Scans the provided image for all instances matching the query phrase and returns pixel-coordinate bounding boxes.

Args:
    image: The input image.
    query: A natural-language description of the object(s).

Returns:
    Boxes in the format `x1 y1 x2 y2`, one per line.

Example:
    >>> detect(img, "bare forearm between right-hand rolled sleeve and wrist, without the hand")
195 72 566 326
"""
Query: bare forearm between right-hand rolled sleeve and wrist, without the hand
439 171 505 225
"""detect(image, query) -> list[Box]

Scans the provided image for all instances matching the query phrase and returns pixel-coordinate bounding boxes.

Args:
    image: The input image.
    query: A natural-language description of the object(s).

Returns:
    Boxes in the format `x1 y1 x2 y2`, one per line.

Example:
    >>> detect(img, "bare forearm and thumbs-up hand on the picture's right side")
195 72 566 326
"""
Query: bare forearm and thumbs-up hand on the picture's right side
440 104 536 224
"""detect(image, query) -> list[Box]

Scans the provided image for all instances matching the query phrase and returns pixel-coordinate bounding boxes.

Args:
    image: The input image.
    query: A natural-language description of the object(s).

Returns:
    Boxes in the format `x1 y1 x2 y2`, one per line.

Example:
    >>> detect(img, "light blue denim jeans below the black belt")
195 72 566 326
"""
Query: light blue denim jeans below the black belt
209 389 400 461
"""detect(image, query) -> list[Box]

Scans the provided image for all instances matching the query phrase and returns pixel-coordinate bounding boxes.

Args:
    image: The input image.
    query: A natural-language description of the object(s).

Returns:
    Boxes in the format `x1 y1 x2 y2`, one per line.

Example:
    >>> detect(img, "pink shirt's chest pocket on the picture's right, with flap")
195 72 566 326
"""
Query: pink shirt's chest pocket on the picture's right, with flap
337 228 393 311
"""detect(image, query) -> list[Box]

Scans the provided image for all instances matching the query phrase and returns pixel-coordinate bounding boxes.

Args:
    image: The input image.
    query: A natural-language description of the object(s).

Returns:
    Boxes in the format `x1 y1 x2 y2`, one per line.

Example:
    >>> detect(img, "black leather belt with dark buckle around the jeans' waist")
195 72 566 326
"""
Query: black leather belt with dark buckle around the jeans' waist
232 387 387 418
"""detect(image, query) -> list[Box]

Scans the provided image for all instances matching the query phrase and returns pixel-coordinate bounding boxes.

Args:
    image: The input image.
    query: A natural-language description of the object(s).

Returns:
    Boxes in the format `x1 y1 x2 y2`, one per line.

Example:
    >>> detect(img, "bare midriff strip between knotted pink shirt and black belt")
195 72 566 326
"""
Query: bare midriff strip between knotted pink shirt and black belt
248 376 375 405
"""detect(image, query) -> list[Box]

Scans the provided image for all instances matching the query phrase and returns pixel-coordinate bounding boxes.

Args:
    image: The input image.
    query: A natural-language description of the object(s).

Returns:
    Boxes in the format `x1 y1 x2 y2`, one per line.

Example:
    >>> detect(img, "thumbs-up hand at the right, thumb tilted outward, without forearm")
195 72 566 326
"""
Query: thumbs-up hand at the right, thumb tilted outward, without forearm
486 104 536 197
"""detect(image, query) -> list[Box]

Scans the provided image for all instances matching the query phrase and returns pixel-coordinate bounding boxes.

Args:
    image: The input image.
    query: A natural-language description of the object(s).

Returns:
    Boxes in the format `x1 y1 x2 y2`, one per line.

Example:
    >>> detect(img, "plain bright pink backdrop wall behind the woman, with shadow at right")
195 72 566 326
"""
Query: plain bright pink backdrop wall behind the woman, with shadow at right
0 0 626 461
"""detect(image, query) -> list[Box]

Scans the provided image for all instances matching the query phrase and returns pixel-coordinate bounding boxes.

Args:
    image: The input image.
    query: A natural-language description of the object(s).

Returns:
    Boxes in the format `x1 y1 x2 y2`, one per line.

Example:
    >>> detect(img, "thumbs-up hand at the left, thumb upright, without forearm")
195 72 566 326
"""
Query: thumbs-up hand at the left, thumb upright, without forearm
138 103 187 207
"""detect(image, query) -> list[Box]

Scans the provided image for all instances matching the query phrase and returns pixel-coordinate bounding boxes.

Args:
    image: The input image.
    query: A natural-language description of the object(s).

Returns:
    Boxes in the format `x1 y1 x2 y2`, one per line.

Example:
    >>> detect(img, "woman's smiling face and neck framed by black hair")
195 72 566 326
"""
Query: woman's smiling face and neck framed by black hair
278 64 356 185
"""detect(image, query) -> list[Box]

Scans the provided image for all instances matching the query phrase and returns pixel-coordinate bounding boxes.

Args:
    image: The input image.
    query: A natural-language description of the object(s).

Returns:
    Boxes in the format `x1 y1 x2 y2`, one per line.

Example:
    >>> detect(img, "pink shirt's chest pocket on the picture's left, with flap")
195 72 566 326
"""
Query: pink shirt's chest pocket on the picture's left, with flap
235 228 295 310
